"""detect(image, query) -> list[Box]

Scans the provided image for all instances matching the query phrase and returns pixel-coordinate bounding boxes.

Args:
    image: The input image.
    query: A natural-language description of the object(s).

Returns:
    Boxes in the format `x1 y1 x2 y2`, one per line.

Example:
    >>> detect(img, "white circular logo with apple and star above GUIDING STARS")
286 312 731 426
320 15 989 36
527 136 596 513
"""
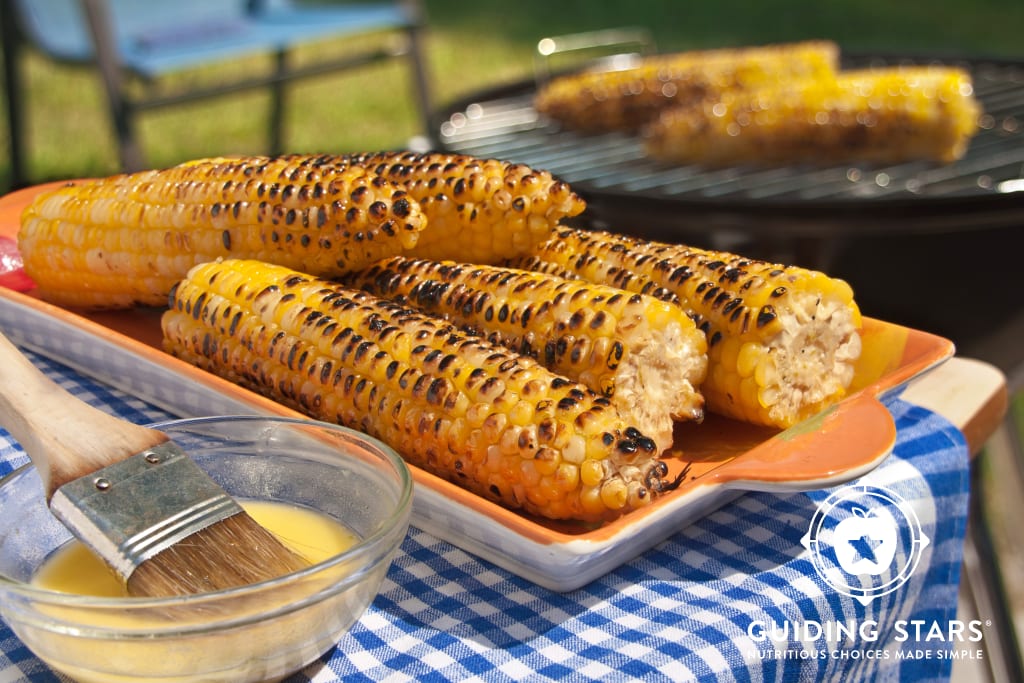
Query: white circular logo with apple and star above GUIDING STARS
801 485 929 605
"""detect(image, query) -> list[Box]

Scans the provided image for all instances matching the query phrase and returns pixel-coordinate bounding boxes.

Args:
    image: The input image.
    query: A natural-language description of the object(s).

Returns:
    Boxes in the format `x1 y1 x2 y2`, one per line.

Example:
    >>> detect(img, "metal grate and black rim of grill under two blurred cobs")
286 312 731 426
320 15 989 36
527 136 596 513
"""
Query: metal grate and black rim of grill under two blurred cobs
435 55 1024 260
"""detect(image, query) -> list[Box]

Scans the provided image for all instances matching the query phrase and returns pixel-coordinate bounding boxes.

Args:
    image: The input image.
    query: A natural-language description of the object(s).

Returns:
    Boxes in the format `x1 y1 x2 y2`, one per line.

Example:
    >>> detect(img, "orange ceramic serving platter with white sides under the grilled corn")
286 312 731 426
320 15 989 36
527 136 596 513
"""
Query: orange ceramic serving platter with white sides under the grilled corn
0 186 953 590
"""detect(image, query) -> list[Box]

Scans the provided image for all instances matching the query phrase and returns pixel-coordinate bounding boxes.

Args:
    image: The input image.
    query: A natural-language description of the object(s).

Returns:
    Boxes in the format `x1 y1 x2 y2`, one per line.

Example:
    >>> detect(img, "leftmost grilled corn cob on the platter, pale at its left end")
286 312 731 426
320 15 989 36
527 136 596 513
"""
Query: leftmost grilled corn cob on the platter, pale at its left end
18 157 426 308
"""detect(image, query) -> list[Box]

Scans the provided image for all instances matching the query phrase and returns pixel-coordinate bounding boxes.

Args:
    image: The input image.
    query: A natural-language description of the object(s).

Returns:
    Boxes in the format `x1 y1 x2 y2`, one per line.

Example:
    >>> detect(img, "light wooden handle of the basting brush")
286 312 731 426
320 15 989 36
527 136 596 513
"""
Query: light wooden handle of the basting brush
0 334 167 501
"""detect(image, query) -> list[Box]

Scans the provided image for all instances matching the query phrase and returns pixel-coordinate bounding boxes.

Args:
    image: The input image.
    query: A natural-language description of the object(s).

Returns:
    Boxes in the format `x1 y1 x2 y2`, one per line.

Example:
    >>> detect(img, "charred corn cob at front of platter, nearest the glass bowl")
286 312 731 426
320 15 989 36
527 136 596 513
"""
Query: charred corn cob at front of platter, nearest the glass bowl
162 259 672 520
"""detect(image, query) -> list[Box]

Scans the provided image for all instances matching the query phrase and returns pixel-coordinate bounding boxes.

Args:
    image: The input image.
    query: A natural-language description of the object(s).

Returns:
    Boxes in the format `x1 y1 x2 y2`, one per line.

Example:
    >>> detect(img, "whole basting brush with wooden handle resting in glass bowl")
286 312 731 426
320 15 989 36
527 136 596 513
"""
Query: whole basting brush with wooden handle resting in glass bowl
0 334 309 597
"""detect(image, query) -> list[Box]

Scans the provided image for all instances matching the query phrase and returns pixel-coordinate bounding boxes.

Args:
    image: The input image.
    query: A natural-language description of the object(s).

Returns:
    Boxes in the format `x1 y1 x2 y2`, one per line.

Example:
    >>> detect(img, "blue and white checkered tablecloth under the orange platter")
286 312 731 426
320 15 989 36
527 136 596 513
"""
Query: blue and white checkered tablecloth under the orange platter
0 355 970 683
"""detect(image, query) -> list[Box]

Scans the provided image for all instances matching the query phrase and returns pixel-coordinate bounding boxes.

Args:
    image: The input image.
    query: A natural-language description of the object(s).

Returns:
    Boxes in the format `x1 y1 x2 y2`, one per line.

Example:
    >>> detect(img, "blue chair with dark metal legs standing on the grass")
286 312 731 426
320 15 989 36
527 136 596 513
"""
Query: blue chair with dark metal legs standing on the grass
0 0 431 187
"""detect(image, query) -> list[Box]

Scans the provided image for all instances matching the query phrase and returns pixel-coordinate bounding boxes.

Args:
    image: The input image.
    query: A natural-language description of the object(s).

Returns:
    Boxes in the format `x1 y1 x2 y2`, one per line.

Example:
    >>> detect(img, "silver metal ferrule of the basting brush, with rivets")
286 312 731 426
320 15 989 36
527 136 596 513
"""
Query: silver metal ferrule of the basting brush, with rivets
50 441 242 581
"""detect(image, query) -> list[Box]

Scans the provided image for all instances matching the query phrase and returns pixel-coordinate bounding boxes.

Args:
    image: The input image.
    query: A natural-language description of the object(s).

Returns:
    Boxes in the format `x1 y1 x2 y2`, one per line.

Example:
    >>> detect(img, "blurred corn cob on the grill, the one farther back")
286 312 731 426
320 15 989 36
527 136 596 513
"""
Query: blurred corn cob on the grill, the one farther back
534 41 839 132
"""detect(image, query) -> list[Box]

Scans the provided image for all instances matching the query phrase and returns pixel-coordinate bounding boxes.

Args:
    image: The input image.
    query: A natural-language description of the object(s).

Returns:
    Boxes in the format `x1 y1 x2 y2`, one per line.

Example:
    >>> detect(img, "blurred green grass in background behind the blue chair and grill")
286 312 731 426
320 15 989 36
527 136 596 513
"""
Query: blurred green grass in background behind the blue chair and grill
0 0 1024 188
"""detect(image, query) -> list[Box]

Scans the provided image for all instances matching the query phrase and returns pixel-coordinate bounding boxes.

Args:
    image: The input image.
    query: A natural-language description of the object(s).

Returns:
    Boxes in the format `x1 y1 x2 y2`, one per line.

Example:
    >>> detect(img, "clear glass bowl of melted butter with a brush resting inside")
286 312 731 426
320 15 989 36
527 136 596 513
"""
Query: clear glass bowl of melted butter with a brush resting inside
0 416 413 683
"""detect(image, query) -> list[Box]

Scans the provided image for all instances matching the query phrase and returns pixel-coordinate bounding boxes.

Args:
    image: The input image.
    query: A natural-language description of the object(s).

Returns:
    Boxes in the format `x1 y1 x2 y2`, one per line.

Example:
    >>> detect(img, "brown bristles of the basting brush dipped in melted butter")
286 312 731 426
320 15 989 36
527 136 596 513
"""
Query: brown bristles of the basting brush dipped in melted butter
128 512 309 597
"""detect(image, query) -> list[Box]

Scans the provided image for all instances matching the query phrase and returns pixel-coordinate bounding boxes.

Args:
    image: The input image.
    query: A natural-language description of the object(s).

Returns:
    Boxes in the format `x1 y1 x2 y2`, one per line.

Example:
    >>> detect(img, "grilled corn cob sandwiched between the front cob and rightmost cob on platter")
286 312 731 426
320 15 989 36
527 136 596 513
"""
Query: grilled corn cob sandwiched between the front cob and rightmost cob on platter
344 256 708 449
